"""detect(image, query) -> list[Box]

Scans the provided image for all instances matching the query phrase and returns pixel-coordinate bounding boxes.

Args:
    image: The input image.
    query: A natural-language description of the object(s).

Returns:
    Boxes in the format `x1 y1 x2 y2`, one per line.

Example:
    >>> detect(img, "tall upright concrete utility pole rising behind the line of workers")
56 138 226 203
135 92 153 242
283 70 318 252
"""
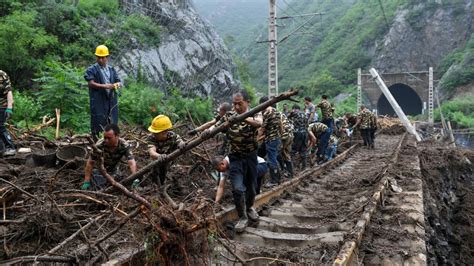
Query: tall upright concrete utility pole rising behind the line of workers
268 0 278 98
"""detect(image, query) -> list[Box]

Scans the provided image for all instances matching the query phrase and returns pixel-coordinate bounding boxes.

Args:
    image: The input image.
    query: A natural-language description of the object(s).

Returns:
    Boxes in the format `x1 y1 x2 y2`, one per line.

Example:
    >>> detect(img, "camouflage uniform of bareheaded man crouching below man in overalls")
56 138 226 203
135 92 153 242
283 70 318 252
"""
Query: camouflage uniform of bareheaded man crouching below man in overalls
90 138 133 189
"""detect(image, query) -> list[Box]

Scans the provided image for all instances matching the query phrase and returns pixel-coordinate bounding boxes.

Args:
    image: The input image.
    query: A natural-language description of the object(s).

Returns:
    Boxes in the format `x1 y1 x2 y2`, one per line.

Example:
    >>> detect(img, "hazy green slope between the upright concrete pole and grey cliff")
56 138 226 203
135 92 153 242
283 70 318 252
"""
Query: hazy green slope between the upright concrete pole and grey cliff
246 0 407 96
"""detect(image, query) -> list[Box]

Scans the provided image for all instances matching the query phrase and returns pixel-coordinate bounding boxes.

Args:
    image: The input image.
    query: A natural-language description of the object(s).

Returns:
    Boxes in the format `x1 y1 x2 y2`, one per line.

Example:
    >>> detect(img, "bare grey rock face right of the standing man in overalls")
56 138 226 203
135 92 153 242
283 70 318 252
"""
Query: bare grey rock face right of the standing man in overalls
114 0 240 101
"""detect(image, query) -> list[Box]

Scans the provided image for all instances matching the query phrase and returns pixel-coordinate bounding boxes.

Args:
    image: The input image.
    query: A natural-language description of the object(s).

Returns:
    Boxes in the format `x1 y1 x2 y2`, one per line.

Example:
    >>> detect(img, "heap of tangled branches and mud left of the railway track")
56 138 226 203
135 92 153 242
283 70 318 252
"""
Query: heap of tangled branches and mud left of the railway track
0 124 226 263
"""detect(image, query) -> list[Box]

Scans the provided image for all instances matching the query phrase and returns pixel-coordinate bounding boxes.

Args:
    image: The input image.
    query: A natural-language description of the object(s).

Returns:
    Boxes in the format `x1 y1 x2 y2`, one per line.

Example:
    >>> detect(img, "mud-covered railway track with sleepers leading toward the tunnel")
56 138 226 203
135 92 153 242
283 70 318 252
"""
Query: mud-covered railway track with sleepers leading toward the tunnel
212 134 420 265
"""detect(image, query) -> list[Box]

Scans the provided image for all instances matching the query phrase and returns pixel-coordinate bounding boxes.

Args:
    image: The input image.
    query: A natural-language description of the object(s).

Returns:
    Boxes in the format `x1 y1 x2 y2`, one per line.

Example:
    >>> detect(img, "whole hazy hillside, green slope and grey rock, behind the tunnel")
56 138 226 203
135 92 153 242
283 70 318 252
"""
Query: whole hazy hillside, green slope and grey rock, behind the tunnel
198 0 474 97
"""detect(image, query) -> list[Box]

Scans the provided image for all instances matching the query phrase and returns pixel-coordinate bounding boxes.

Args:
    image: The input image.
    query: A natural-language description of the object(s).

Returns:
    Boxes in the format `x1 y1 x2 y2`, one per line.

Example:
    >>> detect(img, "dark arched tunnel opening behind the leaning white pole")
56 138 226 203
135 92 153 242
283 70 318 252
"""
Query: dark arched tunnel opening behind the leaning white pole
377 83 423 116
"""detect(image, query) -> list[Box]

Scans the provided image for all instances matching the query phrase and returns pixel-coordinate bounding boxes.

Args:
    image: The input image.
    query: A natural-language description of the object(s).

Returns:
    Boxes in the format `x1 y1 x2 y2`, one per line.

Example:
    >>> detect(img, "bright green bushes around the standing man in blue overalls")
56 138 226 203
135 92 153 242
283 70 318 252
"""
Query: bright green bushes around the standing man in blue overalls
0 0 212 136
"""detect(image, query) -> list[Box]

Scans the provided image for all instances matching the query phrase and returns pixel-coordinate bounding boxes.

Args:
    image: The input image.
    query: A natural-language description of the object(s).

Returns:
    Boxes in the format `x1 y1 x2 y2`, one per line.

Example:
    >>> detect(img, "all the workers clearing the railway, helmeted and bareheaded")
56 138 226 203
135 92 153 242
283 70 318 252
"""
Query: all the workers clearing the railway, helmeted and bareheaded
0 45 375 232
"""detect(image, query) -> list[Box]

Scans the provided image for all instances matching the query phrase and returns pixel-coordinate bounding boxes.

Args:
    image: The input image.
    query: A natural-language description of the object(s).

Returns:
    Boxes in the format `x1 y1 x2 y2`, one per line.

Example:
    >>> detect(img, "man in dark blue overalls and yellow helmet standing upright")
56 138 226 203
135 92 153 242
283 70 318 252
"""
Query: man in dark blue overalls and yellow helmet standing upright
84 45 122 140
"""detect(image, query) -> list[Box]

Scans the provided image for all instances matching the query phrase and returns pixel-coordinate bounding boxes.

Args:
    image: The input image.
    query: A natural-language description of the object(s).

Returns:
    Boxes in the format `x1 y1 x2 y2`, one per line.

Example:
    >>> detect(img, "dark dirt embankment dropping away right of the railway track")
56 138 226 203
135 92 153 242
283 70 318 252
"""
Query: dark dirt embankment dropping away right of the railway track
418 142 474 265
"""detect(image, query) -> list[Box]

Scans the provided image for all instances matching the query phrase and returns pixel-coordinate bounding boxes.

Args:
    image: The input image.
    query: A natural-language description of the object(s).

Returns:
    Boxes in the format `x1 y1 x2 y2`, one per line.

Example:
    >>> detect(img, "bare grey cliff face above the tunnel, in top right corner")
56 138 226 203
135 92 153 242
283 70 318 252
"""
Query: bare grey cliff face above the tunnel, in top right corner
372 0 474 72
